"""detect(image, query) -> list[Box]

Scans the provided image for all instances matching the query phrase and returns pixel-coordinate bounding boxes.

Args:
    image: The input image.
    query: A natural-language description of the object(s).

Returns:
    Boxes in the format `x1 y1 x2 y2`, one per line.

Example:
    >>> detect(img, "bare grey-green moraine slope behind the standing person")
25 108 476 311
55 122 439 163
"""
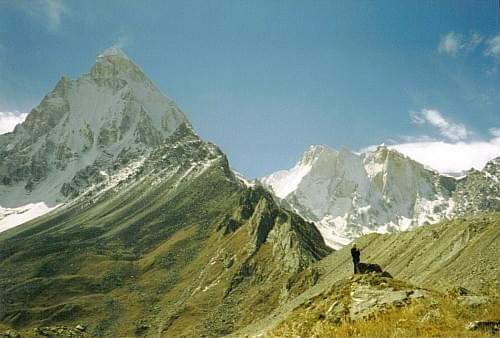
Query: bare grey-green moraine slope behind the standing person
322 213 500 293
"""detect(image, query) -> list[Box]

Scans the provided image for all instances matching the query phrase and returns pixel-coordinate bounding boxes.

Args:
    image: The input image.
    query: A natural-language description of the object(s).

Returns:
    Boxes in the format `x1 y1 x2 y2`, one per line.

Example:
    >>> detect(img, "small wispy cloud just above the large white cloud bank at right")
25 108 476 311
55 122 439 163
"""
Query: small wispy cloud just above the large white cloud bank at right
410 109 470 141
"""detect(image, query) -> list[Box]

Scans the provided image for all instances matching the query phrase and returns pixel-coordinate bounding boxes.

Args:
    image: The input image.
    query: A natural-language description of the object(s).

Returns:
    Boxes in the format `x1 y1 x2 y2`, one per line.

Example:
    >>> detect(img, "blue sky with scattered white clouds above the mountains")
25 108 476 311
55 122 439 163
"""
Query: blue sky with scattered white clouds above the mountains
0 0 500 177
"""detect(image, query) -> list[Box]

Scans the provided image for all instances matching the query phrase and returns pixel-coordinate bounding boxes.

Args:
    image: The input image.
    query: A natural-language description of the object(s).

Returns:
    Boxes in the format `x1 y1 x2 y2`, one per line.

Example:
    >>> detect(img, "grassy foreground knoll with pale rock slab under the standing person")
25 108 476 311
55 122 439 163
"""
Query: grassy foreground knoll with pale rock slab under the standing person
272 274 500 337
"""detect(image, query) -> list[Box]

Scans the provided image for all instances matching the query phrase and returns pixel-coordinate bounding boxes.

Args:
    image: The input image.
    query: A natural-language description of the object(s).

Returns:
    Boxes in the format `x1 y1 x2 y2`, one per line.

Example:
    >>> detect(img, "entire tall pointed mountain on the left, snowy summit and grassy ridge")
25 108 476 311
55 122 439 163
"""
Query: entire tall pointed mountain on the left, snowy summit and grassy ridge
0 50 331 337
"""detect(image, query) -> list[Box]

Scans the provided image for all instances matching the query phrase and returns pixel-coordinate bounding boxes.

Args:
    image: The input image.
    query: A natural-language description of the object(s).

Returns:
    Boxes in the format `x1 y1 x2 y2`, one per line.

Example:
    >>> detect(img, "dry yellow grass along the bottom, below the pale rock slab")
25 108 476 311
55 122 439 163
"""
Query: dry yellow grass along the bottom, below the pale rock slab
266 278 500 337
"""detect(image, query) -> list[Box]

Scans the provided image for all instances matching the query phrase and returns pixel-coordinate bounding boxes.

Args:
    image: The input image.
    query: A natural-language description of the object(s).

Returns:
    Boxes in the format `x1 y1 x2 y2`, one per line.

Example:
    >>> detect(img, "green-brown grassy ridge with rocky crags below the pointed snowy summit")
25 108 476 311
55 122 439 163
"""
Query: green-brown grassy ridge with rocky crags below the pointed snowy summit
0 128 330 337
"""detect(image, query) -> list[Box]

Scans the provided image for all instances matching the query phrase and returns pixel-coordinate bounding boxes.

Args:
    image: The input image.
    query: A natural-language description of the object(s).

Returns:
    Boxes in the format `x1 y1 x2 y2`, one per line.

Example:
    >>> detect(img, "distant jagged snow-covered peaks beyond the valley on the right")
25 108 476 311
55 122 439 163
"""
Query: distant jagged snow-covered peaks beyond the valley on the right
261 146 456 248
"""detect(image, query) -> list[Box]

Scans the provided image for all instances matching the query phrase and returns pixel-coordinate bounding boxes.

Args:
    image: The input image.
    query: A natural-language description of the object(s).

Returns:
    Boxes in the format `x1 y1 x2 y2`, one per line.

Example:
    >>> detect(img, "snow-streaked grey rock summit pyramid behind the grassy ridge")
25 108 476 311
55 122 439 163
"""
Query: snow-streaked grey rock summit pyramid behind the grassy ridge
0 49 189 230
